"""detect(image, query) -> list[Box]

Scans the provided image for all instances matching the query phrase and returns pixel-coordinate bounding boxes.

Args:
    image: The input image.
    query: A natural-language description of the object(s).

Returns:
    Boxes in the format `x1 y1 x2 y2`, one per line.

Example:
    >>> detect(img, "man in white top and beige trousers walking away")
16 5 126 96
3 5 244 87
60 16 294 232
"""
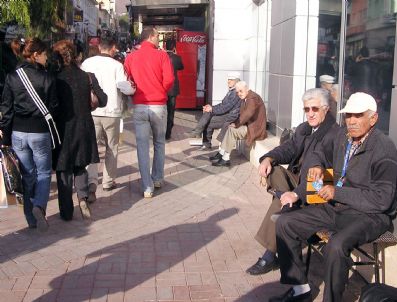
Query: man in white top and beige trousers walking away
81 39 127 202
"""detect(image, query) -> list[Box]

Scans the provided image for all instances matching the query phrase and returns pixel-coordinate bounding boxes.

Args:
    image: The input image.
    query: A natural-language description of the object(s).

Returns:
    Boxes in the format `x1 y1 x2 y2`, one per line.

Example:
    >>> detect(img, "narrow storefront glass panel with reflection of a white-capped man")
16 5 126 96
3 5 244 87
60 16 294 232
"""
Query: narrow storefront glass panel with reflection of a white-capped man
316 0 342 116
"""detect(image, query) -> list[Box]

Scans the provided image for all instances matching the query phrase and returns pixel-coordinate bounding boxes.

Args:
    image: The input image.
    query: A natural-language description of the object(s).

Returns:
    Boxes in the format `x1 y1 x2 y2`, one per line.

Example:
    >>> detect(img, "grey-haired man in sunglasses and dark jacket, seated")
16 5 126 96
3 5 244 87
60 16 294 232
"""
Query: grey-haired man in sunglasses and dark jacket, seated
247 88 339 275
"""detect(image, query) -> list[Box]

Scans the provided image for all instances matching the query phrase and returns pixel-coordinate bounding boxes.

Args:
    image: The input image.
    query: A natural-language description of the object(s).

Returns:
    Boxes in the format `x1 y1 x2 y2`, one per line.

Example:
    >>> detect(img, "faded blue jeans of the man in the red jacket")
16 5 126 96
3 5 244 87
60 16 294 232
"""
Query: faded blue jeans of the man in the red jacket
132 105 167 192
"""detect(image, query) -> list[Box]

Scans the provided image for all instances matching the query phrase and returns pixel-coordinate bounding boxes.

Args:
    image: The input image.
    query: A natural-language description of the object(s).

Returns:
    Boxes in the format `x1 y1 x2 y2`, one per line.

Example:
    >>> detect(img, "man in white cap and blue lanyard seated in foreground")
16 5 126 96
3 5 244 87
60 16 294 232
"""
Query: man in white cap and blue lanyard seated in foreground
269 92 397 302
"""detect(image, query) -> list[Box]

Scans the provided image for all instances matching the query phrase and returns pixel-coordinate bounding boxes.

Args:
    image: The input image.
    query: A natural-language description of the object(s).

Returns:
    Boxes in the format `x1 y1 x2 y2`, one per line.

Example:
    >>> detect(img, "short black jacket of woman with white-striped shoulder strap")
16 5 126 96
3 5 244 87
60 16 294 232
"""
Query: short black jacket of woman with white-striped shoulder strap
0 62 59 144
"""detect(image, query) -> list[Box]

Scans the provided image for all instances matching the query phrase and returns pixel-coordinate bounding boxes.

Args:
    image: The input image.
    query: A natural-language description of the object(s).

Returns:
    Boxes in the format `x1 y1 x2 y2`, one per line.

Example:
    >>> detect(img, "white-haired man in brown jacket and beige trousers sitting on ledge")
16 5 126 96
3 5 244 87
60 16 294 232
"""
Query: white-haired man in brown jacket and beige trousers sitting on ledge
210 81 267 167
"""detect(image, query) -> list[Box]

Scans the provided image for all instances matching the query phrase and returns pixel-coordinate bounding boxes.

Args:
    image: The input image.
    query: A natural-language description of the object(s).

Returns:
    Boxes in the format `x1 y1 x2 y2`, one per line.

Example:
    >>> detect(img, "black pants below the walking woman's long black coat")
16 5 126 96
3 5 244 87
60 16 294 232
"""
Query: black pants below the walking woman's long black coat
56 167 88 220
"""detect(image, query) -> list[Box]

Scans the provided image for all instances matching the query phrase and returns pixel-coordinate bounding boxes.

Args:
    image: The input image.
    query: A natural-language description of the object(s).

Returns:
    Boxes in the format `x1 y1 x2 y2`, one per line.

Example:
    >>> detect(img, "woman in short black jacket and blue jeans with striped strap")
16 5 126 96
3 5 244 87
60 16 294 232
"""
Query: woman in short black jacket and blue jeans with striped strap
0 38 58 231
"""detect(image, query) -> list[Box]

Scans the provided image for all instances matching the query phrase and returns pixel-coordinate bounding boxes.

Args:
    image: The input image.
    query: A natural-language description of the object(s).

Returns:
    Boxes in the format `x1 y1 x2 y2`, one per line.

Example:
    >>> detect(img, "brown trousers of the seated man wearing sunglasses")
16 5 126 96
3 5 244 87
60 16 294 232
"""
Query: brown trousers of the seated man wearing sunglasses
255 166 298 253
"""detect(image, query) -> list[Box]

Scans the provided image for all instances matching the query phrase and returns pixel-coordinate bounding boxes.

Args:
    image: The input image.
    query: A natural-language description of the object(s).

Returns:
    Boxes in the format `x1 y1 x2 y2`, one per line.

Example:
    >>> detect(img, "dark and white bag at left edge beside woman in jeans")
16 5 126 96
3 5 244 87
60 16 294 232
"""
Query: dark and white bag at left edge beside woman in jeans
0 146 23 208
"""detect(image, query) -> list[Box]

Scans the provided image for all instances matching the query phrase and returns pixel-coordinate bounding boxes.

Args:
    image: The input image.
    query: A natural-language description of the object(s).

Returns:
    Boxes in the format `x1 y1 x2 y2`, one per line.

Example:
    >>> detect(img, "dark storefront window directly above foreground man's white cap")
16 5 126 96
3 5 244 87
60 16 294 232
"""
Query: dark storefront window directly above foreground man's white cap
343 0 397 134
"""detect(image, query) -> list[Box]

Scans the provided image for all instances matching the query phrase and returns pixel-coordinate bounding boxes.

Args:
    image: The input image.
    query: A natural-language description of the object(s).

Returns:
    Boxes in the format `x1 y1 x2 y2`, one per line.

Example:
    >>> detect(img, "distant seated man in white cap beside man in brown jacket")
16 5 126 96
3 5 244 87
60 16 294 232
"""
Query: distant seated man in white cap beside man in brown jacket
187 72 241 150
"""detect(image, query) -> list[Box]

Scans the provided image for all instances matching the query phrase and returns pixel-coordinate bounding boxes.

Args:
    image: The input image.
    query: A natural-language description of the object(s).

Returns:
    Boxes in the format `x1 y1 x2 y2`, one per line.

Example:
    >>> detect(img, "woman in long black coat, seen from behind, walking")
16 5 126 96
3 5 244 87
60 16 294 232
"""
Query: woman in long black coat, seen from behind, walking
53 40 107 220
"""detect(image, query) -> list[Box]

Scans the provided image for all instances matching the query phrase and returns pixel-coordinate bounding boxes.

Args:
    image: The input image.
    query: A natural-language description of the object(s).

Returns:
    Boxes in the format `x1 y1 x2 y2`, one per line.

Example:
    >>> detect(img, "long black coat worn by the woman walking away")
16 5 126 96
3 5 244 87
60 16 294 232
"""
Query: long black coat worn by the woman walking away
53 65 107 171
